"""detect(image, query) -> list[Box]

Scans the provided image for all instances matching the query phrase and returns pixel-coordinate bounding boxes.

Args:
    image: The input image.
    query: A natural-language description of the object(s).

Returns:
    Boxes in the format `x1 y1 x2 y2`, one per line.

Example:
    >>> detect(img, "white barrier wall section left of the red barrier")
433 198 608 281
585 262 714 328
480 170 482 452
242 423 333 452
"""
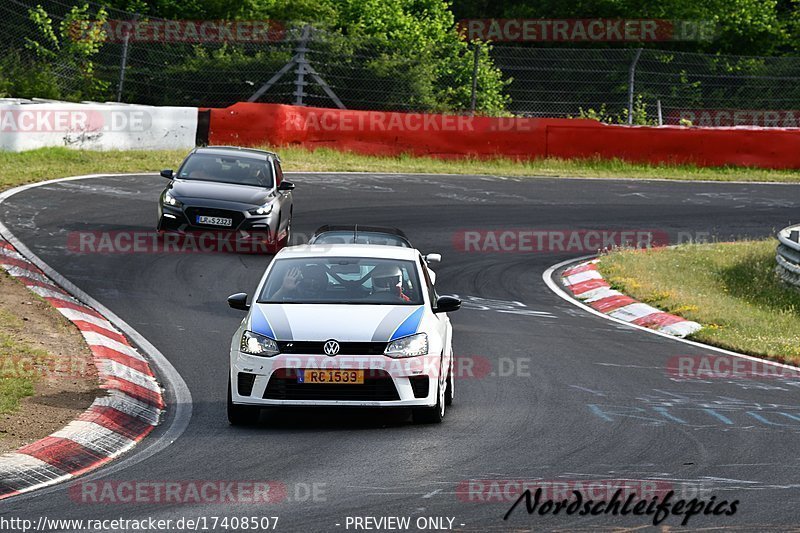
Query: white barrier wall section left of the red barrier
0 100 197 152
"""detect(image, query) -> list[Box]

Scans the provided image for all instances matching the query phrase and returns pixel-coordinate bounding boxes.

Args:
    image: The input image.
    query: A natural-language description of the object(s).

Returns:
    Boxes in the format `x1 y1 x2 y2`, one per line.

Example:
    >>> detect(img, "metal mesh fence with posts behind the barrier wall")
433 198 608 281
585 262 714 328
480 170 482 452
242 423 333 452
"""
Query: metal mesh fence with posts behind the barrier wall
0 0 800 126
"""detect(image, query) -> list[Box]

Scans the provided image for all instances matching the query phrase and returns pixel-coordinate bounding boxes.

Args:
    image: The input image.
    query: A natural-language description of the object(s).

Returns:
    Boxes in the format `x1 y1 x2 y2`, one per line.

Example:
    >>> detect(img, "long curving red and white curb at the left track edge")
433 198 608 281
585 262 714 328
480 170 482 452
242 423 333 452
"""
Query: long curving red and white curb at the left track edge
0 237 164 499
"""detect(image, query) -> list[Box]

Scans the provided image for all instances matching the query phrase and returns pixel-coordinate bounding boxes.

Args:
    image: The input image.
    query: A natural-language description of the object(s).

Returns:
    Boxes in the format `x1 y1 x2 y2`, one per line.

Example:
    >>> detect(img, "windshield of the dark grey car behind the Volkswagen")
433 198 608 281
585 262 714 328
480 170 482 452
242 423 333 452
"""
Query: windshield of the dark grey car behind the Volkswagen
178 154 274 187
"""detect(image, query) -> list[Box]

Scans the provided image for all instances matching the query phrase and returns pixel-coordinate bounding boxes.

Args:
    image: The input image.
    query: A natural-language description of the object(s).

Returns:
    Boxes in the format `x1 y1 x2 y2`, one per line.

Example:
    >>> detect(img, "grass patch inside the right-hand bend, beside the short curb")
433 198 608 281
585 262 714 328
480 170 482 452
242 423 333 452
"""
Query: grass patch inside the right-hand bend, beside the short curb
600 239 800 364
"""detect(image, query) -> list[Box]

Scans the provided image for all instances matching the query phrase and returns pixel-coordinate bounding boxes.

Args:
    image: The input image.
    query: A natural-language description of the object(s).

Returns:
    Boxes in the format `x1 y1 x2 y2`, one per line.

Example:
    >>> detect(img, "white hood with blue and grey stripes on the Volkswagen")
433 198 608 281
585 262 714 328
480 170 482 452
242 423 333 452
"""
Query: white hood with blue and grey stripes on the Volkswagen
247 304 424 342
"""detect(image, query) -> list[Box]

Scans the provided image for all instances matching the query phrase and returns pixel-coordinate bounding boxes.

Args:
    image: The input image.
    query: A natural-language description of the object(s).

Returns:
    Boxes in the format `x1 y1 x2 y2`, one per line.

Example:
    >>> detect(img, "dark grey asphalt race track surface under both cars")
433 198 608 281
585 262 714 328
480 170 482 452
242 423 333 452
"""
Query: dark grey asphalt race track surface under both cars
0 174 800 531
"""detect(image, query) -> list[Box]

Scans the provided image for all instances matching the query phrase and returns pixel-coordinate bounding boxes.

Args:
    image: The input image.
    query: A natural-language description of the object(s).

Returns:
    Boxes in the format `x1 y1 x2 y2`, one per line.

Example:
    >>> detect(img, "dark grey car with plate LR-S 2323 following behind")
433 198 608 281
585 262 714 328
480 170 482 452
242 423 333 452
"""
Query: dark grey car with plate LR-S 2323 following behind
157 146 294 251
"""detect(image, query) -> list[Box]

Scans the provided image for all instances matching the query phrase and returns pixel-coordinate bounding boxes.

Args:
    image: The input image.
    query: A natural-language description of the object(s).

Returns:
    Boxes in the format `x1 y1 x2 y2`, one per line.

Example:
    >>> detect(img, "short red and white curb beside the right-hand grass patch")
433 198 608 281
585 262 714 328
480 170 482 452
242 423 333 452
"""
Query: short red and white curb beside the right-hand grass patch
561 259 703 338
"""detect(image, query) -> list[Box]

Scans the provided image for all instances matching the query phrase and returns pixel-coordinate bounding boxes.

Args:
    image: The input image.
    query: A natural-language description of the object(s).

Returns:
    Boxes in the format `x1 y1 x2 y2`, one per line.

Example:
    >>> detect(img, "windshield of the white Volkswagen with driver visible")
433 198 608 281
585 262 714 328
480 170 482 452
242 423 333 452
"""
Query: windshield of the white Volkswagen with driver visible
258 257 423 305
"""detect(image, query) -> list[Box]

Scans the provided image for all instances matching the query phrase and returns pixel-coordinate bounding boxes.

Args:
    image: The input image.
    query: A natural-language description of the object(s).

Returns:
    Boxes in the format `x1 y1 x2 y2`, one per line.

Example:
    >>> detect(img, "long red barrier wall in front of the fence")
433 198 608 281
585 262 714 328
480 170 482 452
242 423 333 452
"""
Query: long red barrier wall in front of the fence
209 103 800 168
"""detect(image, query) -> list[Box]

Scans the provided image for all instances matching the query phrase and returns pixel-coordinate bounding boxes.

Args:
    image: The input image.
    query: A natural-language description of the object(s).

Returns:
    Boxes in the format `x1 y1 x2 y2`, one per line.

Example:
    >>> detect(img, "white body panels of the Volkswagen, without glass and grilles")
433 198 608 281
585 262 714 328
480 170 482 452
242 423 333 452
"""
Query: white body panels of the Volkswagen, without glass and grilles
230 244 452 407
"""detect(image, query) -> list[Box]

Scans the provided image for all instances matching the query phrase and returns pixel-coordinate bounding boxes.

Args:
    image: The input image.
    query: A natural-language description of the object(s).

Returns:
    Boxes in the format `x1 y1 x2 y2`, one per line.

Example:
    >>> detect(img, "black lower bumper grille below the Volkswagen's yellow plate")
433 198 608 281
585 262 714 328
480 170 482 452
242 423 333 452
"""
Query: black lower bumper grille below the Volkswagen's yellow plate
263 369 400 401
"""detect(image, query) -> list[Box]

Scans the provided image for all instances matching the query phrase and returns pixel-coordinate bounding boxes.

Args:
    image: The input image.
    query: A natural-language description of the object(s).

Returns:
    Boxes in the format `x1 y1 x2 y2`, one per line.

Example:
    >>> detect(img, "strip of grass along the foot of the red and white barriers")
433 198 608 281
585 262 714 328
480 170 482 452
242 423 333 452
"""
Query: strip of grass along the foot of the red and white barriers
0 146 800 189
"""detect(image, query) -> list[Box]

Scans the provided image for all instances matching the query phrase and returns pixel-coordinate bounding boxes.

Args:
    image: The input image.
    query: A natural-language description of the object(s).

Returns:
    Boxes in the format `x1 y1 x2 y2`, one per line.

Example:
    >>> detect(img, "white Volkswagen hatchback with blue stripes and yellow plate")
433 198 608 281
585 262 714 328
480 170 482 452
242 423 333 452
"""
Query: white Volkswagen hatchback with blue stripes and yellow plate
228 244 461 425
